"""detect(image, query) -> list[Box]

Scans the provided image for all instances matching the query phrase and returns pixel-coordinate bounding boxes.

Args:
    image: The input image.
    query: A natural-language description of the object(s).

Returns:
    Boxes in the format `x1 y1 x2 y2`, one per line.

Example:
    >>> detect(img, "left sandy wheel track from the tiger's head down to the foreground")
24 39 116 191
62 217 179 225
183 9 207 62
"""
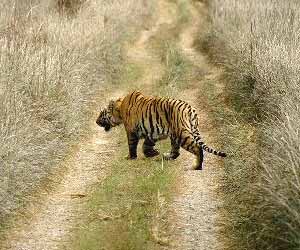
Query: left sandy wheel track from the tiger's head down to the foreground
4 89 123 250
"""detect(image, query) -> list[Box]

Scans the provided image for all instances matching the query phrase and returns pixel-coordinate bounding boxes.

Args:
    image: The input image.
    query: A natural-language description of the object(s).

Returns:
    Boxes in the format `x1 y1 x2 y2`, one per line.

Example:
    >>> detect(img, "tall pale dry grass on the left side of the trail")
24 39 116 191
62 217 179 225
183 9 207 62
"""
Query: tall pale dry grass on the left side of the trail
0 0 151 228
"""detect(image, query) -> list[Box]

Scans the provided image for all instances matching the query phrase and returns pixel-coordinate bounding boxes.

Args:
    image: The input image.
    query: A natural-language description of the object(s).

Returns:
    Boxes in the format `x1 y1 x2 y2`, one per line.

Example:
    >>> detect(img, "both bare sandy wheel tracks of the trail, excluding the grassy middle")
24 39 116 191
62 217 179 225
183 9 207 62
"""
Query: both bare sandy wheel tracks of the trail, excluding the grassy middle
4 0 222 250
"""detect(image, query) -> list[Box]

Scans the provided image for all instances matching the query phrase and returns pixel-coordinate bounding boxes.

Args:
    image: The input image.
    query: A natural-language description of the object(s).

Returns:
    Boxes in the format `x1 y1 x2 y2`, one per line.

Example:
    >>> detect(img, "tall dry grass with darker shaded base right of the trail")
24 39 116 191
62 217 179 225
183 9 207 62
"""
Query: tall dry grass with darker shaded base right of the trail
202 0 300 249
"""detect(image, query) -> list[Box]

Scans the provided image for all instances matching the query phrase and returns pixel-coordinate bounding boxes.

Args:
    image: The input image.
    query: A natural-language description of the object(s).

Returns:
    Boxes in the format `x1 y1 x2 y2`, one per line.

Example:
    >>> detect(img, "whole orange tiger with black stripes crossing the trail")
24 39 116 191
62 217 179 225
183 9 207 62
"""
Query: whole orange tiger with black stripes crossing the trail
96 91 226 170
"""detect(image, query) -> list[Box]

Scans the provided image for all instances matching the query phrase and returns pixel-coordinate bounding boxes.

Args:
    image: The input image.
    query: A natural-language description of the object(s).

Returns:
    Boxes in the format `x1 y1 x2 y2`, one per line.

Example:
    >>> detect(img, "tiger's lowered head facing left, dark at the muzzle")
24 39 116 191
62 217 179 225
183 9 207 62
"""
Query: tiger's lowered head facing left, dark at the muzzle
96 98 123 131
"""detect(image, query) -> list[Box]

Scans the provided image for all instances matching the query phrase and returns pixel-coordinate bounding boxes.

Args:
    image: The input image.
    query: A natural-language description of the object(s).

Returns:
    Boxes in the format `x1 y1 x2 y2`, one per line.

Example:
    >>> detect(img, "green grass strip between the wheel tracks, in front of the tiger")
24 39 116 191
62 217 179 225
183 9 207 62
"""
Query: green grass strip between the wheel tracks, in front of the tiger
72 128 176 250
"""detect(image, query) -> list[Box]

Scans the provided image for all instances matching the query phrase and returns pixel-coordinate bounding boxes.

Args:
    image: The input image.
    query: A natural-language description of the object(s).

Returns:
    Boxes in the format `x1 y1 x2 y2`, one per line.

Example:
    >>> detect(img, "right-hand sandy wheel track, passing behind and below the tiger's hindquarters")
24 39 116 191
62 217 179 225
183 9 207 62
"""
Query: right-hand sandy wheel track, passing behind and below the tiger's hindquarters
171 3 223 250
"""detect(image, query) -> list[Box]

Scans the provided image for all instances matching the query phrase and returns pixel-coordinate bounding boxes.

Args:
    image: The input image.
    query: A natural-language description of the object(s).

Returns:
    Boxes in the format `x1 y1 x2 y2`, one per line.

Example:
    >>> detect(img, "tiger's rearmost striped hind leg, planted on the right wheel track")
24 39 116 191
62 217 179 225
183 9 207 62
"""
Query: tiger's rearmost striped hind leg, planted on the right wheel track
181 133 204 170
